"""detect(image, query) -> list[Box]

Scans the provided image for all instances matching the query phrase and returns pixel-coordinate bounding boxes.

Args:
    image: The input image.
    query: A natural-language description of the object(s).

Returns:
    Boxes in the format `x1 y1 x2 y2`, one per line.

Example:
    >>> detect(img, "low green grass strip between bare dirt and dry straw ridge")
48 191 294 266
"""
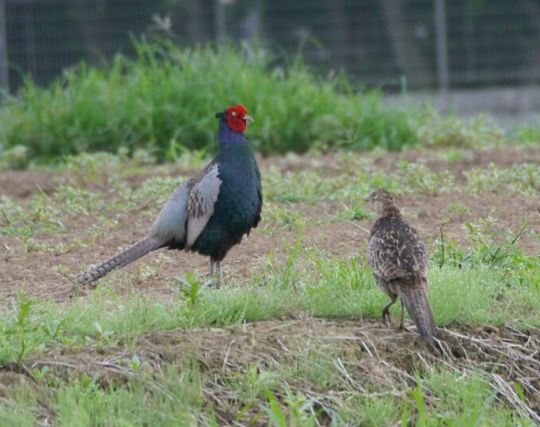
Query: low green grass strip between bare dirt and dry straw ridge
0 249 540 364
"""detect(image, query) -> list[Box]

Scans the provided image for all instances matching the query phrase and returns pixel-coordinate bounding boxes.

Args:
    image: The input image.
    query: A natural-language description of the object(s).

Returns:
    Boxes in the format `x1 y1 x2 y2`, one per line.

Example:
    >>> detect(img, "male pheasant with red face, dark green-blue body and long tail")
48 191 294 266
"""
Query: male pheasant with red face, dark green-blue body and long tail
79 105 263 285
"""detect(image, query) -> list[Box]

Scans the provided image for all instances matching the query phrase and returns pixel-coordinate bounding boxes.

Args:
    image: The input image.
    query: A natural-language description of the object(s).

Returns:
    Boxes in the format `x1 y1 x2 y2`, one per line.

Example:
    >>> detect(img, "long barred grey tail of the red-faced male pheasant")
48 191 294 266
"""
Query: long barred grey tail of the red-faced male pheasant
78 237 162 285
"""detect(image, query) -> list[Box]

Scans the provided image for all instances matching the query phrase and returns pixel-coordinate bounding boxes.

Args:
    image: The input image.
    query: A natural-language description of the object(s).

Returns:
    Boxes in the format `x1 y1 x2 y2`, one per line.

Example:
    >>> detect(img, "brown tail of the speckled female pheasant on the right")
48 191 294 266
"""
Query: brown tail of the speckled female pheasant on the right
399 283 435 344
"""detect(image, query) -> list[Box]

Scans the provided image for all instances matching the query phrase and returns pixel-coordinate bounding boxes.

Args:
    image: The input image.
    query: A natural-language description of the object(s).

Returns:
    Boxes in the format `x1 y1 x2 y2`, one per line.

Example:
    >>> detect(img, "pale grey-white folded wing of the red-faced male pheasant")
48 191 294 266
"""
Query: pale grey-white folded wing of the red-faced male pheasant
186 165 221 249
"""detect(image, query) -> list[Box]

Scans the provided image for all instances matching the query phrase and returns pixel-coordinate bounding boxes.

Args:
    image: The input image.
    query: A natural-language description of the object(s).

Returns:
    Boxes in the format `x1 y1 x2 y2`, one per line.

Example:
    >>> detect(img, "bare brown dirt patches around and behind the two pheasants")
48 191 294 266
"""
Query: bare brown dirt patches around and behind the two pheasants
0 146 540 300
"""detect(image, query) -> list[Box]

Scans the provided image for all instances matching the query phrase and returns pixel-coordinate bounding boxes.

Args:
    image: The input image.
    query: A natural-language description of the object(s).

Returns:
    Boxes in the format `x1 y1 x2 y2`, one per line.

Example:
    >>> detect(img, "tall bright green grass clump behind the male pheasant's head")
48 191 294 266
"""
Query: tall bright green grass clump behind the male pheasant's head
0 41 415 164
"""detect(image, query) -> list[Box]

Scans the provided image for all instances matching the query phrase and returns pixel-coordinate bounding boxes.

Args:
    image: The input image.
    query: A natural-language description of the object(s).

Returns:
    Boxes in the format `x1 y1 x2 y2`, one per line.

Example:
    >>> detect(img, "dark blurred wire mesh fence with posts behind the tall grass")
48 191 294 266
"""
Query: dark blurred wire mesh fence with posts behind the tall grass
0 0 540 92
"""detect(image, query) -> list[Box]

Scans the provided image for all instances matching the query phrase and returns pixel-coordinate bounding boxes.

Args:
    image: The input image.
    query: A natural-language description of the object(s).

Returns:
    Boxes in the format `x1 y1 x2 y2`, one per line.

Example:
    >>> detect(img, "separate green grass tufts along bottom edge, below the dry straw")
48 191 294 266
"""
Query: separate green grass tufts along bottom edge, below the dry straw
0 361 532 427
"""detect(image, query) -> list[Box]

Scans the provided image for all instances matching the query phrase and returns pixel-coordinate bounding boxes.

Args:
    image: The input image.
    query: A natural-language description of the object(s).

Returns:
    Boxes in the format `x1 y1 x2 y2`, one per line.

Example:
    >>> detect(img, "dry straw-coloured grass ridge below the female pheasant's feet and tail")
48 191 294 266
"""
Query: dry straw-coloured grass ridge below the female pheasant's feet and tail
2 318 540 425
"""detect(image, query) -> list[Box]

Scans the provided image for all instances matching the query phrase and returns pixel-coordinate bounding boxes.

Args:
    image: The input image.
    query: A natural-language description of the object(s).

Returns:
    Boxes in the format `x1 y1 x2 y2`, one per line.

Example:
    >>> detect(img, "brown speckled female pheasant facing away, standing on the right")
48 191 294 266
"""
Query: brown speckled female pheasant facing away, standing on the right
367 189 435 342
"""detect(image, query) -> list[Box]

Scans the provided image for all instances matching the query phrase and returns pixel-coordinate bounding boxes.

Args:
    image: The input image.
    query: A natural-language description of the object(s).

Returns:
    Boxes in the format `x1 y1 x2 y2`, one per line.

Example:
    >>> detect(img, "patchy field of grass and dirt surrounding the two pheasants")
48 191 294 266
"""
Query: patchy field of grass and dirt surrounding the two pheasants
0 146 540 426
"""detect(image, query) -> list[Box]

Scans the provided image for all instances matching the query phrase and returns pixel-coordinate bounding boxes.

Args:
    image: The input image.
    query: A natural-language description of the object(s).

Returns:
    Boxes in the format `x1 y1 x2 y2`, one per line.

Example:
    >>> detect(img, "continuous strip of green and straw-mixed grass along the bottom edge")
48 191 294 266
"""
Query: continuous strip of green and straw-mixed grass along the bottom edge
0 343 533 427
